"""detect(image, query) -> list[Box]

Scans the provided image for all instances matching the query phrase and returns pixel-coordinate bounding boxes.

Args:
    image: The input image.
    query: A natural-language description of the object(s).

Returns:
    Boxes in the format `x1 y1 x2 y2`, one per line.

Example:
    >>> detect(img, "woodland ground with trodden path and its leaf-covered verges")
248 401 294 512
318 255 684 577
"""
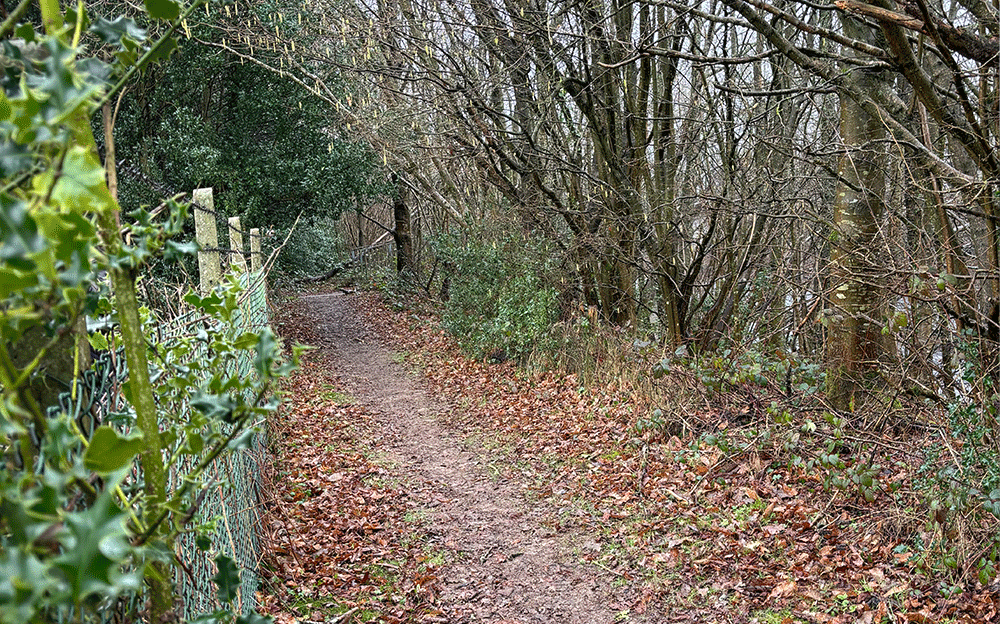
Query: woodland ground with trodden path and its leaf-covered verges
268 294 1000 624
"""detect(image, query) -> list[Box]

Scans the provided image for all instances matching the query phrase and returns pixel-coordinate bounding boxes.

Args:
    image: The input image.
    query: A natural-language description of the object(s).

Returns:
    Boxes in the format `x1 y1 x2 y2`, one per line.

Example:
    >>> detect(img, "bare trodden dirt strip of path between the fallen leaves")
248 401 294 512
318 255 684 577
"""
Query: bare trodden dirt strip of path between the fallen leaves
292 293 637 624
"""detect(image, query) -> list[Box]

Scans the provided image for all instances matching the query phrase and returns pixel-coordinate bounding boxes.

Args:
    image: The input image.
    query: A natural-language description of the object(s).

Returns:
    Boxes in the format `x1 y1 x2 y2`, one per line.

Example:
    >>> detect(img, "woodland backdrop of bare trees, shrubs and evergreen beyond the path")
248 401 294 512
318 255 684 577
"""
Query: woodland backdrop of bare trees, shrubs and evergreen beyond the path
0 0 1000 620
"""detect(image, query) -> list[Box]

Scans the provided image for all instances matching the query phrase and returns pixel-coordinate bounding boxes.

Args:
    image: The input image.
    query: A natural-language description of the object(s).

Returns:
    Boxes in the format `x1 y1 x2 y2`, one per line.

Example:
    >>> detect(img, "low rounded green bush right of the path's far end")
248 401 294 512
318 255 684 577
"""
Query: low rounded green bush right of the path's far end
435 228 558 359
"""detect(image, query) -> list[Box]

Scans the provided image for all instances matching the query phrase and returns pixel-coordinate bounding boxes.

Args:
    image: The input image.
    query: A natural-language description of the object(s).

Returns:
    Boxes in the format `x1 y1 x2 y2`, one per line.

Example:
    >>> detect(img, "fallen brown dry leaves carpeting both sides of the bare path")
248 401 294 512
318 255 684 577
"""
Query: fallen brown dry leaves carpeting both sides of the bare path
267 295 998 624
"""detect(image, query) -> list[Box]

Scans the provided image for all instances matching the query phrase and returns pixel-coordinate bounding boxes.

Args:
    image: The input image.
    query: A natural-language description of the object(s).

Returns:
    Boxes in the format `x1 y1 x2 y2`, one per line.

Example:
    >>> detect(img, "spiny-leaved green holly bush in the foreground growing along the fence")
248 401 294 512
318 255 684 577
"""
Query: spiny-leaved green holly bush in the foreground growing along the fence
0 0 292 624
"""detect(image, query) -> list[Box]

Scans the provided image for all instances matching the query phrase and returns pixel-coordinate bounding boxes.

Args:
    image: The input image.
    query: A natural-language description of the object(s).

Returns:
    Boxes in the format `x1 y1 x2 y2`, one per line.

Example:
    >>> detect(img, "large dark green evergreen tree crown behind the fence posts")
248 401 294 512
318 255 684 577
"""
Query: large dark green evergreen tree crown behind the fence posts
107 23 381 235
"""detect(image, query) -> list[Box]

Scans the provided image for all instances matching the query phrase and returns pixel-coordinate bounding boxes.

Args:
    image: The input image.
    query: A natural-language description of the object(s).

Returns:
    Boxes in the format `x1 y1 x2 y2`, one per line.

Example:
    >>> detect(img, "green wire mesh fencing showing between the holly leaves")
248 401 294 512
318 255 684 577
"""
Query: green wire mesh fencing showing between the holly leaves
49 273 269 623
